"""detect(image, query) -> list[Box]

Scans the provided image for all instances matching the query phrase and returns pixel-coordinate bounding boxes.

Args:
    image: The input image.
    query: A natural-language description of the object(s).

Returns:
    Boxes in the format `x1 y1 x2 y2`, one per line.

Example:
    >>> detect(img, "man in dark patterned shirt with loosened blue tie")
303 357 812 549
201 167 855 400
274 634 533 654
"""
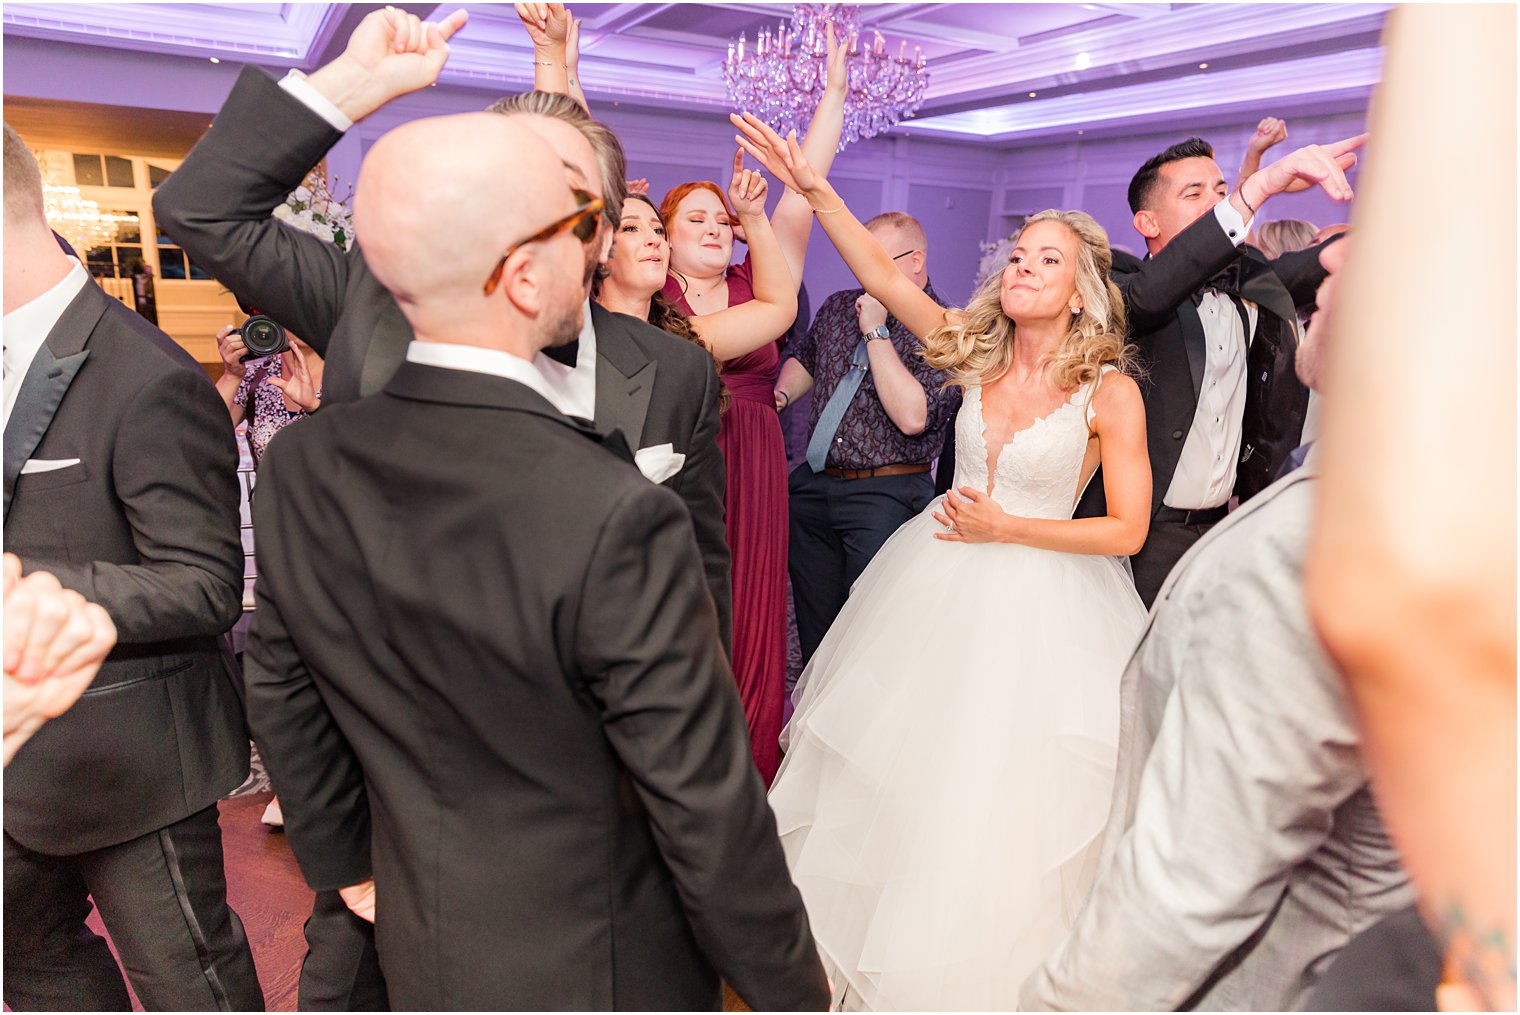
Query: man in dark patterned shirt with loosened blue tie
775 211 961 666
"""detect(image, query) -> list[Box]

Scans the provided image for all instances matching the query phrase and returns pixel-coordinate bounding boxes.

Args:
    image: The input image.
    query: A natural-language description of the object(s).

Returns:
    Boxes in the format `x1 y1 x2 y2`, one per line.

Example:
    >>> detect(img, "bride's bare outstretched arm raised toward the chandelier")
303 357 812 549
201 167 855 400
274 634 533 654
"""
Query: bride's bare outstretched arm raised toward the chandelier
728 112 945 339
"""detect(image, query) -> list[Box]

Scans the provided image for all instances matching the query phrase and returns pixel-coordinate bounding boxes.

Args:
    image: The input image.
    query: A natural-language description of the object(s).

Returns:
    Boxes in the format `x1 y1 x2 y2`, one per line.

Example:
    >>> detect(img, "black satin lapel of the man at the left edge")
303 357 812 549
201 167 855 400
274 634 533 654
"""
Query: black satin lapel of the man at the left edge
5 281 109 514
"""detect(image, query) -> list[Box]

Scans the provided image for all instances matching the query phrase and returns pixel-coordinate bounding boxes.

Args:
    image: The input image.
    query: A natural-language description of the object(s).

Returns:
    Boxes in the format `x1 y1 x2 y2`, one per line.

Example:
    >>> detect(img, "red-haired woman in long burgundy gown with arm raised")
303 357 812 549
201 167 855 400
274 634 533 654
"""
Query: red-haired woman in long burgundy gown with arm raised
660 43 845 786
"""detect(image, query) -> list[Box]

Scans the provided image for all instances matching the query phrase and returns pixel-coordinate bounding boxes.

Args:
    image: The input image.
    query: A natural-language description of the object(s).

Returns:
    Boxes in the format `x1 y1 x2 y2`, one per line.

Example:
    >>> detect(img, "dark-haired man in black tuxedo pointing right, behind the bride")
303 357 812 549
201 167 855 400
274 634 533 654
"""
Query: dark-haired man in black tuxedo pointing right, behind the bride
1076 129 1362 606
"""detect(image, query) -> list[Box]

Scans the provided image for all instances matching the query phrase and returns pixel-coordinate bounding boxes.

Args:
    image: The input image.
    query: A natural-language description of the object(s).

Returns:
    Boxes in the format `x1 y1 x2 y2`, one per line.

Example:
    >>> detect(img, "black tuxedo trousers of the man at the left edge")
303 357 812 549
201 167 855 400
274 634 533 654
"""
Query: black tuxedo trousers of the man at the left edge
5 804 264 1012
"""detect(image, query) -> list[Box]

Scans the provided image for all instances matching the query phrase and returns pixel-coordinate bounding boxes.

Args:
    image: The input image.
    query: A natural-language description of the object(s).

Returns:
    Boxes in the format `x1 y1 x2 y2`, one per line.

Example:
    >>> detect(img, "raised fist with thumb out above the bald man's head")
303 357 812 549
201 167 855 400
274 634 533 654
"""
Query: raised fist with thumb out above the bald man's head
307 8 470 120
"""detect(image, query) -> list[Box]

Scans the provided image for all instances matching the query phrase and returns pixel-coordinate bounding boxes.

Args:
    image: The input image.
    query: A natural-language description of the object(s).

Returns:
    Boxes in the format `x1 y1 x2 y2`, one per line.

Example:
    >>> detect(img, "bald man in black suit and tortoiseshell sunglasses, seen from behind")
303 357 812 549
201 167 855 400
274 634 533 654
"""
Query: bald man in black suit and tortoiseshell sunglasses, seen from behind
246 112 828 1010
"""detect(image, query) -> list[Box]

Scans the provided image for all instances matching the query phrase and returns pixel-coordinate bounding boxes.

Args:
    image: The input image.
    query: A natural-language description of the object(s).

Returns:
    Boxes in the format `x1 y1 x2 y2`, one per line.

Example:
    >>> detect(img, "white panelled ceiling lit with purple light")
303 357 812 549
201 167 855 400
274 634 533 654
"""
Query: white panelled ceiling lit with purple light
3 3 1394 144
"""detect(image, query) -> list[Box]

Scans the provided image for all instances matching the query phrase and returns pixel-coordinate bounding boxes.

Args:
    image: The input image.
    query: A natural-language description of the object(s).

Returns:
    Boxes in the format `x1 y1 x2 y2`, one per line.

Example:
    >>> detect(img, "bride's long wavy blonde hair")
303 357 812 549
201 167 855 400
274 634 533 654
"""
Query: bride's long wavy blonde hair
924 208 1134 391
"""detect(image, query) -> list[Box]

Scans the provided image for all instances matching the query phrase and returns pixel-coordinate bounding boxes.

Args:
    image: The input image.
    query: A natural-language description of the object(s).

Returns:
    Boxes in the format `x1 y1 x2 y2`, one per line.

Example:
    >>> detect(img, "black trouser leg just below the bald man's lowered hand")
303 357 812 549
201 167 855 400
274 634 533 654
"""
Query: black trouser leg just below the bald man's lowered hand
296 890 391 1012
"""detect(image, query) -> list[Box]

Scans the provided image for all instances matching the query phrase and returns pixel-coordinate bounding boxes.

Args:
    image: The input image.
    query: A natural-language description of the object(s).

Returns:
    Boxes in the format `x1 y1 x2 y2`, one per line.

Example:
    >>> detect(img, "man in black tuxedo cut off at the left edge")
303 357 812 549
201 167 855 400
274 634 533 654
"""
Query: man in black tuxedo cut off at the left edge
5 126 264 1010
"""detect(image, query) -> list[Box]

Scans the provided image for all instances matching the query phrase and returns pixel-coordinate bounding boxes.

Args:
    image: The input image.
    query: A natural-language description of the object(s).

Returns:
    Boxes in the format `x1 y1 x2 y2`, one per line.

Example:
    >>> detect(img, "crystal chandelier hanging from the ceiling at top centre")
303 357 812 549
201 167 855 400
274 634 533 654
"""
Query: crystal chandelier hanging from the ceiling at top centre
724 3 929 150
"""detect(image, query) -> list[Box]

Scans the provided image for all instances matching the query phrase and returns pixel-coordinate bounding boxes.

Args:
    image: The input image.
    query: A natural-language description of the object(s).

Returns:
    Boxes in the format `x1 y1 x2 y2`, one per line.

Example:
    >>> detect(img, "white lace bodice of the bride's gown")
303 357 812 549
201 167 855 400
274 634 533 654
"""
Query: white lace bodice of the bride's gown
955 366 1113 518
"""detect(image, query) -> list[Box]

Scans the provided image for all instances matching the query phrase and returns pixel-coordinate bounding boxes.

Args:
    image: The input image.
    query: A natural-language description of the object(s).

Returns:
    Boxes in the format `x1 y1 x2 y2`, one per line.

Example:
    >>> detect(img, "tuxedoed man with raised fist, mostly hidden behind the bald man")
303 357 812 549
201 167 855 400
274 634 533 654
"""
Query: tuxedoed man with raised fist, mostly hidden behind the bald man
154 8 733 649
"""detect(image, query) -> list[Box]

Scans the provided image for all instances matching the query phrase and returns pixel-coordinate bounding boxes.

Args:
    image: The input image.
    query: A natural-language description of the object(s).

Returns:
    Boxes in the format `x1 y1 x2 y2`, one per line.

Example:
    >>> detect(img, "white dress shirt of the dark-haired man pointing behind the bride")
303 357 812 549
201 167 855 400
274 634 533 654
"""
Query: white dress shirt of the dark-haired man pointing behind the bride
1161 201 1257 511
